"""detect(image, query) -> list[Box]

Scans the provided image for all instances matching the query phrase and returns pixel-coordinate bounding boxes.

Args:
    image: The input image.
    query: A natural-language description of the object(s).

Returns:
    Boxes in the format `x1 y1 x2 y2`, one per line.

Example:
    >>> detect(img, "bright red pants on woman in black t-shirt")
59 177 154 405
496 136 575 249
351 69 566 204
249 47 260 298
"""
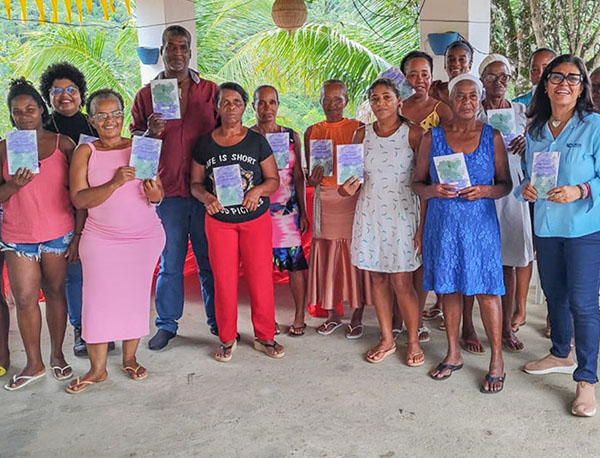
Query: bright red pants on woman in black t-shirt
205 211 275 342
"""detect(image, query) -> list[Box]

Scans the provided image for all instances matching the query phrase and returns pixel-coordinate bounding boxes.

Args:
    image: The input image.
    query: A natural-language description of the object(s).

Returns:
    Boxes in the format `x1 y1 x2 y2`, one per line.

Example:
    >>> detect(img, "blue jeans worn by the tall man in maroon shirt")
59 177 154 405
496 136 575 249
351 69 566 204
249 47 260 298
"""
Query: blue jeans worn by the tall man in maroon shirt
155 197 217 334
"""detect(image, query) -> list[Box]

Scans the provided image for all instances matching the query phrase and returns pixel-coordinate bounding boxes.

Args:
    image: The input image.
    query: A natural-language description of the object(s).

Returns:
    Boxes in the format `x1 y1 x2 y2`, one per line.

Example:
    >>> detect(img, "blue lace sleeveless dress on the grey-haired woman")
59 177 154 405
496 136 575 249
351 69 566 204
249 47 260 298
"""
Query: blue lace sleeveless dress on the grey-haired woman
423 124 505 296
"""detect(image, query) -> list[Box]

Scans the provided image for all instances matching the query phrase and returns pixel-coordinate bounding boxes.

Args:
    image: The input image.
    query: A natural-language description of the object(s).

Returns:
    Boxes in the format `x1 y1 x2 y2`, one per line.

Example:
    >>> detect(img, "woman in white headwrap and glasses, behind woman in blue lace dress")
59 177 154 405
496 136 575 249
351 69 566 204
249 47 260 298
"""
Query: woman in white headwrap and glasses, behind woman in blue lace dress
479 54 534 352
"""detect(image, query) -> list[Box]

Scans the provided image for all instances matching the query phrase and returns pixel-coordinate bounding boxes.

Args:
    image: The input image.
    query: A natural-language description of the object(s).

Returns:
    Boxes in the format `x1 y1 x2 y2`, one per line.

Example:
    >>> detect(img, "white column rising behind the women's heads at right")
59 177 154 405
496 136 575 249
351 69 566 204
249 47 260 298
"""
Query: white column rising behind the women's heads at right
420 0 491 80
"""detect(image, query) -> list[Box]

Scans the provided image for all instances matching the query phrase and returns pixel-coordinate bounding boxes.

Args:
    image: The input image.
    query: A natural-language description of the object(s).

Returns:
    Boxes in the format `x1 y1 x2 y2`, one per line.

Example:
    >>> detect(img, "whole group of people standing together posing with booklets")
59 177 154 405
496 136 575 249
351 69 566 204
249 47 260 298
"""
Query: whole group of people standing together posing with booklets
0 26 600 416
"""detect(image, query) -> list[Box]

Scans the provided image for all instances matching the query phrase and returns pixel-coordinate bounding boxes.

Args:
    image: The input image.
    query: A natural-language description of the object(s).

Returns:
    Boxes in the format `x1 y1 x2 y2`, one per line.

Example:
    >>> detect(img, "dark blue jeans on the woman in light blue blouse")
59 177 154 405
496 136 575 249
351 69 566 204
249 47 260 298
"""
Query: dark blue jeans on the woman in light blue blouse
537 232 600 383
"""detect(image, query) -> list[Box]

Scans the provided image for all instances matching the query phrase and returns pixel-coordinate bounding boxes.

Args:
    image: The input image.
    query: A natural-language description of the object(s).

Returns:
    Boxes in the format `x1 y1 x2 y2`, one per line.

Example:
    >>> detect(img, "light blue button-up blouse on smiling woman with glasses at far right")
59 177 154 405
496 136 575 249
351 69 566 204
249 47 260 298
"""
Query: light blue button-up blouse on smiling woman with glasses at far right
514 113 600 237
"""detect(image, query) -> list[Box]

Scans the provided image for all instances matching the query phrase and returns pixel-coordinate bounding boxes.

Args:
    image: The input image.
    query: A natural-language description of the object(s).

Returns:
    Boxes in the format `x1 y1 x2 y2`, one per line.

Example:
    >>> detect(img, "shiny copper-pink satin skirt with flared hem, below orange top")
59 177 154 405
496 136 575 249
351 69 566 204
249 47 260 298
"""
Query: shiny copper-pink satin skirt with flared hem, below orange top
308 187 371 315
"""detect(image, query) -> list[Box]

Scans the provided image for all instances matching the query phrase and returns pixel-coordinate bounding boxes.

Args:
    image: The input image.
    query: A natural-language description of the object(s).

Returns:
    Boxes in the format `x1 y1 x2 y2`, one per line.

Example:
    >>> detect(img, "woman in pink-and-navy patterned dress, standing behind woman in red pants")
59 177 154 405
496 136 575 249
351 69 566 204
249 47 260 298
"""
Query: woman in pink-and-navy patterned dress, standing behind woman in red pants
252 85 308 336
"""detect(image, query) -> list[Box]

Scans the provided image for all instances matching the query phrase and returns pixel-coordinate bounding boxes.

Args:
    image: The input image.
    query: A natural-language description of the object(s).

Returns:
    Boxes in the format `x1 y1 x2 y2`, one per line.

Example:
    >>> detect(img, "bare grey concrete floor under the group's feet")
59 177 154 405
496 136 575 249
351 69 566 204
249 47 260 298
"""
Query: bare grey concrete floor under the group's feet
0 279 600 458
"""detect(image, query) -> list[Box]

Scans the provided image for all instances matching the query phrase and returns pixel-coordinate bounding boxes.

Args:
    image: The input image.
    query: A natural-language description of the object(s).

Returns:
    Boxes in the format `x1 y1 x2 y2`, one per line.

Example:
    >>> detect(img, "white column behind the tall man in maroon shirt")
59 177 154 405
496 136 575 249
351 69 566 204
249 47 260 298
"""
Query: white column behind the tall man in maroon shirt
135 0 197 84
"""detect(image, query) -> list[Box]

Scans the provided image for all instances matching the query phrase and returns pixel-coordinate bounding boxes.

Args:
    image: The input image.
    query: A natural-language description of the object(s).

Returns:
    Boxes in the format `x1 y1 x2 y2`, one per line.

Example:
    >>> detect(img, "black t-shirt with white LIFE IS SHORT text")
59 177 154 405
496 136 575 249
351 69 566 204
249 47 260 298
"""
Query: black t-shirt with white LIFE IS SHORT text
193 129 273 223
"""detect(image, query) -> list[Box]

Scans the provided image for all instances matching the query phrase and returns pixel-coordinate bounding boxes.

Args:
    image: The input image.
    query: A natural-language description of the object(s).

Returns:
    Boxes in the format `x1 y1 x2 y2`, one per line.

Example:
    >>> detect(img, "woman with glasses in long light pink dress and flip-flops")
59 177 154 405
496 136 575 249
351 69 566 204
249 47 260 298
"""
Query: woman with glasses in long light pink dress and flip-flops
67 89 165 394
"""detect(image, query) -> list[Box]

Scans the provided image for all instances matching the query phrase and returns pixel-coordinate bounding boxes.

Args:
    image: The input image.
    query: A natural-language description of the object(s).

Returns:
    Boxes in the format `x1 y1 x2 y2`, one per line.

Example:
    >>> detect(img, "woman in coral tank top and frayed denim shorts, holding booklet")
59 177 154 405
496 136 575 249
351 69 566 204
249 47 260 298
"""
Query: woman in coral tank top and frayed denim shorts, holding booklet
0 78 75 391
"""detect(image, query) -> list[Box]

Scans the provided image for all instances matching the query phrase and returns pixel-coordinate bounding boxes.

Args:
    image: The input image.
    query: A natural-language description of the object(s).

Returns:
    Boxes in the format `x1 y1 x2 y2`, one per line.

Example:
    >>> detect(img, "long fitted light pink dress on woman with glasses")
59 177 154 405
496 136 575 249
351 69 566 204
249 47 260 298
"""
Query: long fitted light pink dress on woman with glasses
79 143 165 344
